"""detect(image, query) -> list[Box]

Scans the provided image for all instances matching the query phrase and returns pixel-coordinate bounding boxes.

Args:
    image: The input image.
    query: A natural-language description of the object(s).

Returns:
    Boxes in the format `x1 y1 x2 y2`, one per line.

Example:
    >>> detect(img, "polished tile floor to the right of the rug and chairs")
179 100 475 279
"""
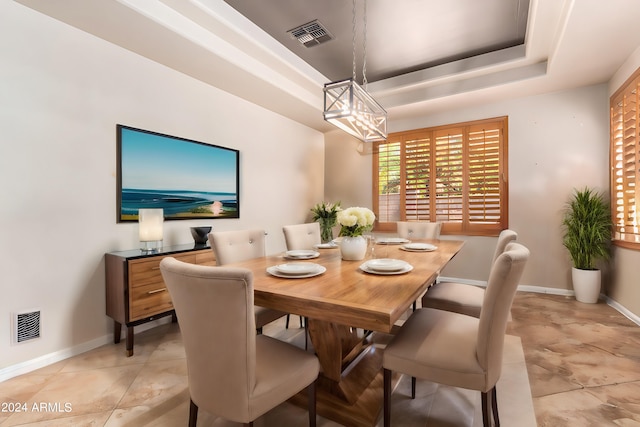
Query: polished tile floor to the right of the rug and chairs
508 293 640 427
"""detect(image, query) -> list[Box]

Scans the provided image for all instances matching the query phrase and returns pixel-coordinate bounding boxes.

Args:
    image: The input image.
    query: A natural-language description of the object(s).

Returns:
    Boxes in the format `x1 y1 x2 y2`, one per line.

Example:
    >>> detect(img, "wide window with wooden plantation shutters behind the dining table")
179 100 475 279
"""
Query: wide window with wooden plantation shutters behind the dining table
373 117 508 236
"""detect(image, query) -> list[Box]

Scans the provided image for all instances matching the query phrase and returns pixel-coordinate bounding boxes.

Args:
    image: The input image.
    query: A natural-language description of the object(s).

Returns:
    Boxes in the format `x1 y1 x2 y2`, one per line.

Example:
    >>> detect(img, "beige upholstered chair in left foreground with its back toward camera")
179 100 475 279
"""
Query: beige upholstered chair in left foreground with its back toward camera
160 257 320 427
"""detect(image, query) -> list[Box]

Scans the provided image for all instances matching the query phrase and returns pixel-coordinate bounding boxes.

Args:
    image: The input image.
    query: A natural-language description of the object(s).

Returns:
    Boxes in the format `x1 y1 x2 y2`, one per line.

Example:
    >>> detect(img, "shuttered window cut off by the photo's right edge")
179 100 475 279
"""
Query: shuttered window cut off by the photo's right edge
609 69 640 249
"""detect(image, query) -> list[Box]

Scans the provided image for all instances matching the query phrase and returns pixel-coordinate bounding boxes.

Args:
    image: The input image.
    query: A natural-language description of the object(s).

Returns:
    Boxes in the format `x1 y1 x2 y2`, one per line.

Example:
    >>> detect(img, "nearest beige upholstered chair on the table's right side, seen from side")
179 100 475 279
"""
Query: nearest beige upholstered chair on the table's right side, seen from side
382 243 529 427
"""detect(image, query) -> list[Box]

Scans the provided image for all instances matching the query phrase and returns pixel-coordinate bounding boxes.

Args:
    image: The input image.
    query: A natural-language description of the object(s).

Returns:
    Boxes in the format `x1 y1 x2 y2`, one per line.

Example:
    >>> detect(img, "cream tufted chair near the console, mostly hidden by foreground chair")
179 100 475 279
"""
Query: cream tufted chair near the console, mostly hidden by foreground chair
209 229 287 333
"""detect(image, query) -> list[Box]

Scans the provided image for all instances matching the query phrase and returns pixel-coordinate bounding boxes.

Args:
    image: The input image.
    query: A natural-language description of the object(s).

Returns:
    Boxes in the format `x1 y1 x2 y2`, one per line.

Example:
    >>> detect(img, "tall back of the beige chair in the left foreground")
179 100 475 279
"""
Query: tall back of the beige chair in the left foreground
160 257 256 419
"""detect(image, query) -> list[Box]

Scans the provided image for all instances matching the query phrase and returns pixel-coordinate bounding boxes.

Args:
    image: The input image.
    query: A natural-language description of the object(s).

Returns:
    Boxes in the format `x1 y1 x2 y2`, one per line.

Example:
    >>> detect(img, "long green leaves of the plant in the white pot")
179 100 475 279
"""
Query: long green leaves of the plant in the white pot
562 187 612 270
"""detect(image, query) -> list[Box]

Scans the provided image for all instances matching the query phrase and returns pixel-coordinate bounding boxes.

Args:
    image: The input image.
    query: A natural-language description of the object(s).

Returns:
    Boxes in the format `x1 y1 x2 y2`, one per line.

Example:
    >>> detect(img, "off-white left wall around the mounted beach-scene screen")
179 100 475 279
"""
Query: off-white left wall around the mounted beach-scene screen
0 2 324 369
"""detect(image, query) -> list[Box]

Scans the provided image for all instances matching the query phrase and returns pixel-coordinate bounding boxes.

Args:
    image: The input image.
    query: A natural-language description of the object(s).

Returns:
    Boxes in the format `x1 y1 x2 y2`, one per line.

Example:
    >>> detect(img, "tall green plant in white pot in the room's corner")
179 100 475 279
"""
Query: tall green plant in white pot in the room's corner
562 187 612 303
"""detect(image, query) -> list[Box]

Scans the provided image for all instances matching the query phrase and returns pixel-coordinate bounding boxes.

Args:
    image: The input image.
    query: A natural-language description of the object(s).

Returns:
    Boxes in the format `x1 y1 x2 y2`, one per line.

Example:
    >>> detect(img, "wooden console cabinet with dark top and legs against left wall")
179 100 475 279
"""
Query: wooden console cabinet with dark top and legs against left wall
105 244 216 356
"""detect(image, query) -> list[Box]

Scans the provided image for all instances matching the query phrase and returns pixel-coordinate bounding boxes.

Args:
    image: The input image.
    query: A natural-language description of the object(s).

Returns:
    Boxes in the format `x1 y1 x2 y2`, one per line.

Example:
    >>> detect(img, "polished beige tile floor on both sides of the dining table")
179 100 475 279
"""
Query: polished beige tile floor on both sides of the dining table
0 293 640 427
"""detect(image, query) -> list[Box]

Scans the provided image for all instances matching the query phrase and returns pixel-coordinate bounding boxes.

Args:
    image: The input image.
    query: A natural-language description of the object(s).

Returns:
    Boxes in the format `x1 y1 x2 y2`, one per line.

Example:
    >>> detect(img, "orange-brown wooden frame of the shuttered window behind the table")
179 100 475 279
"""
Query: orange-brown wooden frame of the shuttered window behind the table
372 116 509 236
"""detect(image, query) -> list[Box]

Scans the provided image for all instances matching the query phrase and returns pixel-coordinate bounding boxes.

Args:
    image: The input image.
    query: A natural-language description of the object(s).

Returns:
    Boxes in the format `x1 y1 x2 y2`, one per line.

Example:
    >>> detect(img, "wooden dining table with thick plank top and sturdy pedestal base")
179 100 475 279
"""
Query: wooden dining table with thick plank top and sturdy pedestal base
230 240 464 426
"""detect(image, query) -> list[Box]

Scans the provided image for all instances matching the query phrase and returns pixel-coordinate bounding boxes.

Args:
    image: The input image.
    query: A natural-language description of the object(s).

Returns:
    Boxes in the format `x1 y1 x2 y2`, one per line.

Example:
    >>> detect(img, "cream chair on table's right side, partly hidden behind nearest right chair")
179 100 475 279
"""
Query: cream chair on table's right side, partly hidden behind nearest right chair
422 229 518 317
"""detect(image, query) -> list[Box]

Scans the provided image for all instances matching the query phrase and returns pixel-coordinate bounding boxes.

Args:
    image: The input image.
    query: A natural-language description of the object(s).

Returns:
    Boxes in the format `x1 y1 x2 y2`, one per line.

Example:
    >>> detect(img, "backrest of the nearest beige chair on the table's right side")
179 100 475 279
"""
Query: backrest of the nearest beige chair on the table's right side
476 243 529 390
